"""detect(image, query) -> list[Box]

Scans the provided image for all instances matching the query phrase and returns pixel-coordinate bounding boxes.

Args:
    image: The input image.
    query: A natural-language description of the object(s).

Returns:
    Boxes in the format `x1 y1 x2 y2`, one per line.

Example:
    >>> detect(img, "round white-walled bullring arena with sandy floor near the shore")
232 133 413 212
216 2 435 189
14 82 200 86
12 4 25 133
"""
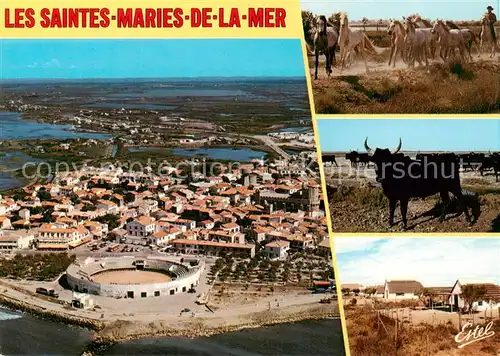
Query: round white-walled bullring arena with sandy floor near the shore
66 257 204 298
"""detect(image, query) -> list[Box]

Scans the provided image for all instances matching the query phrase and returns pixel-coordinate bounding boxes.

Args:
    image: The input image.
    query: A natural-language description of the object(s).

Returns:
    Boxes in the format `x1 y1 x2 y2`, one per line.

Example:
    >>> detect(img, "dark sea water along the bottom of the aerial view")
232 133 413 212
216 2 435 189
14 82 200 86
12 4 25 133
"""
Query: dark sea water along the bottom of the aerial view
0 308 345 356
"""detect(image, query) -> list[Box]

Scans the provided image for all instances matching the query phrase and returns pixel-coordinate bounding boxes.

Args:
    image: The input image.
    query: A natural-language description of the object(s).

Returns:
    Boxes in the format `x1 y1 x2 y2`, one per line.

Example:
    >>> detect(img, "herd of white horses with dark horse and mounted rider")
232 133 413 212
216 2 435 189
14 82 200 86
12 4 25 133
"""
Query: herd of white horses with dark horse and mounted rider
308 13 498 79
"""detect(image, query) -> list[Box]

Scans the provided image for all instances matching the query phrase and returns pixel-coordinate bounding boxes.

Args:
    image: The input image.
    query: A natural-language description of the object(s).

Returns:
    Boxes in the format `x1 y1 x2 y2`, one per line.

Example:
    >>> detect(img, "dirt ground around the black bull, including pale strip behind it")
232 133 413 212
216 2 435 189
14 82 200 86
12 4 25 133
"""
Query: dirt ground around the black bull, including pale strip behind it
324 155 500 232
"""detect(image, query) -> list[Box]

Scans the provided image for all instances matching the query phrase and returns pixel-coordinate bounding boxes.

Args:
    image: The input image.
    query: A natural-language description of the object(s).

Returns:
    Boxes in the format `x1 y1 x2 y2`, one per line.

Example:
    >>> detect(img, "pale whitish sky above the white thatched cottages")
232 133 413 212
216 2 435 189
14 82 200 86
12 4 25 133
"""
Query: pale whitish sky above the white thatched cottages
334 237 500 287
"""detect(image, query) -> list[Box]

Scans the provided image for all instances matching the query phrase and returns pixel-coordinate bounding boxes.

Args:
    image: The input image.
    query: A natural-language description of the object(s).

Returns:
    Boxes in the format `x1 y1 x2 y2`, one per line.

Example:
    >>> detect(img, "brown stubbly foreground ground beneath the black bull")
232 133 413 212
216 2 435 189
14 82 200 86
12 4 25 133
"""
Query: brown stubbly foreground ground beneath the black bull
328 184 500 232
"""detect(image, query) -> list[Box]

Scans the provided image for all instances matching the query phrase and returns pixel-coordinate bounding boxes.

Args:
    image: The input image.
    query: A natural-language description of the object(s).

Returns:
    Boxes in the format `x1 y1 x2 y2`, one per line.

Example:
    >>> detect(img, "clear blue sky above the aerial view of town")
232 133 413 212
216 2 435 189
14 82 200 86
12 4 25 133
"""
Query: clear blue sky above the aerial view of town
0 39 305 79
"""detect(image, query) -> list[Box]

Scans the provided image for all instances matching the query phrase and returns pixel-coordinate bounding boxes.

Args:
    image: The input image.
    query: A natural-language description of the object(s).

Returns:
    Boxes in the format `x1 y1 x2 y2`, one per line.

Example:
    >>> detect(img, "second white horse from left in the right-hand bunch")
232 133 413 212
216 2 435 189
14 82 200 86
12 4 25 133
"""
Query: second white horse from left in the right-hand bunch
405 18 431 68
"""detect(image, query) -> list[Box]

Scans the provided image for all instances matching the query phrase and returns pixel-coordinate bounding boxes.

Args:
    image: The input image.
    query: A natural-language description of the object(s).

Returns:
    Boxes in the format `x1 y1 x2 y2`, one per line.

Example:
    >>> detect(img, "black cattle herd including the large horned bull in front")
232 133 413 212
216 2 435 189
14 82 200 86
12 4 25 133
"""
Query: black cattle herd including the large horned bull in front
322 138 500 229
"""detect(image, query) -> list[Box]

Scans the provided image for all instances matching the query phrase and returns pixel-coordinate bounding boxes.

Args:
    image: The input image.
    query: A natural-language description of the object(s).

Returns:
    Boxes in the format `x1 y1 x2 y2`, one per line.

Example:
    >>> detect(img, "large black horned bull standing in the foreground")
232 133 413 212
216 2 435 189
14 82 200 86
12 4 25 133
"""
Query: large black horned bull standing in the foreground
365 137 471 229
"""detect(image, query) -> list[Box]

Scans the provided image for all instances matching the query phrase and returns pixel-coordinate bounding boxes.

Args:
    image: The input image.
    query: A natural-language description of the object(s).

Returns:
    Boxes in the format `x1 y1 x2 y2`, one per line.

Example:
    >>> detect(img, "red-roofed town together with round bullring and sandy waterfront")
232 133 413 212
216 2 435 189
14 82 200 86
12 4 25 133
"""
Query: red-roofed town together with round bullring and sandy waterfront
0 145 337 344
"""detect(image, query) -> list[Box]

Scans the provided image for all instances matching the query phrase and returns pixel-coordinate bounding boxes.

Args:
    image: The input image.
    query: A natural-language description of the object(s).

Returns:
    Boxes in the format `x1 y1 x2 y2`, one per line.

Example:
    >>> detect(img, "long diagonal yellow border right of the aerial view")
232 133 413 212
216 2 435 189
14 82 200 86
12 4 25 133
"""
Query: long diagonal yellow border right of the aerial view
300 29 351 356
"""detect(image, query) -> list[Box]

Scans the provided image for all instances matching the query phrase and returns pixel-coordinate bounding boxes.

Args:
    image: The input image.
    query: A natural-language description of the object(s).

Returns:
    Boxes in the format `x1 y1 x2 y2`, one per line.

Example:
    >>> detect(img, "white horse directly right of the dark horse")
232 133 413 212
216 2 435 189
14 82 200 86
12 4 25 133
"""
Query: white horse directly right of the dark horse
339 13 377 73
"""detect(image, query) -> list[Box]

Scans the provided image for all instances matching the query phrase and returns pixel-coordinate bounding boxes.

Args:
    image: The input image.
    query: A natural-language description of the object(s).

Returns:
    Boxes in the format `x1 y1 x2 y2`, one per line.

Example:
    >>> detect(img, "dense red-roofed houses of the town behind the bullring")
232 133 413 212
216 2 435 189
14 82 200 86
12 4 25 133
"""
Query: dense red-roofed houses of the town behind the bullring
0 156 329 257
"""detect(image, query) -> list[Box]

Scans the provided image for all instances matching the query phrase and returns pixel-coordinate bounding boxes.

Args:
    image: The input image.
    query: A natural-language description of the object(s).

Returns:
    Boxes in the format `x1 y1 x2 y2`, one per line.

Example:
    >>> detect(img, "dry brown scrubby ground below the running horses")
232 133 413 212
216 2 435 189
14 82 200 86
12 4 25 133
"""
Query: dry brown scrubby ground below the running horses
309 48 500 114
